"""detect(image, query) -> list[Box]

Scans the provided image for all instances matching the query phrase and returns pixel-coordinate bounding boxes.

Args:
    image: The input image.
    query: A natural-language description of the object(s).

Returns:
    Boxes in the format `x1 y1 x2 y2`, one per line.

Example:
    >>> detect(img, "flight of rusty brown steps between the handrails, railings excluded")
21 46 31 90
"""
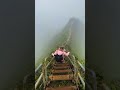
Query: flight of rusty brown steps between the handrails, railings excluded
46 63 78 90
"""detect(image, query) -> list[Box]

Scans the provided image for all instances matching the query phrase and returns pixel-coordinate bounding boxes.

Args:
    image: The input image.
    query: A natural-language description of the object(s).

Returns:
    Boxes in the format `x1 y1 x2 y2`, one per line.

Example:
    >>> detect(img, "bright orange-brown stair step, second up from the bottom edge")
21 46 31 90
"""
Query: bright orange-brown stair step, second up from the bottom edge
49 74 73 81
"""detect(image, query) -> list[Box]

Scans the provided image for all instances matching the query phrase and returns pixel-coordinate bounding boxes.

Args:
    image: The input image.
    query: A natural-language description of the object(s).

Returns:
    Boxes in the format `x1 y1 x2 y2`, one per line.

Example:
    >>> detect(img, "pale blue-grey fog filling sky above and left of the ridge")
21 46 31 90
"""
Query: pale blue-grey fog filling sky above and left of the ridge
35 0 85 62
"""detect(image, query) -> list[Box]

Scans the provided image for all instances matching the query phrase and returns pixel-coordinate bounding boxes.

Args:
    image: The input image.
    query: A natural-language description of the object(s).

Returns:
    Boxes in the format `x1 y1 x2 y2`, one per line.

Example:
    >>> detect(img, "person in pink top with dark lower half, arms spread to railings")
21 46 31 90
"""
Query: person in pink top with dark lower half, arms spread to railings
52 47 70 63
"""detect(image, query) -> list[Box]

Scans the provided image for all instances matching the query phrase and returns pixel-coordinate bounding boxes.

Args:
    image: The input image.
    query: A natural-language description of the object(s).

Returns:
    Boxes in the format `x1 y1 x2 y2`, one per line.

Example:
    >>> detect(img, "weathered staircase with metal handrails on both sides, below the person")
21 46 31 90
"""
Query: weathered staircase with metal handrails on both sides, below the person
35 55 85 90
